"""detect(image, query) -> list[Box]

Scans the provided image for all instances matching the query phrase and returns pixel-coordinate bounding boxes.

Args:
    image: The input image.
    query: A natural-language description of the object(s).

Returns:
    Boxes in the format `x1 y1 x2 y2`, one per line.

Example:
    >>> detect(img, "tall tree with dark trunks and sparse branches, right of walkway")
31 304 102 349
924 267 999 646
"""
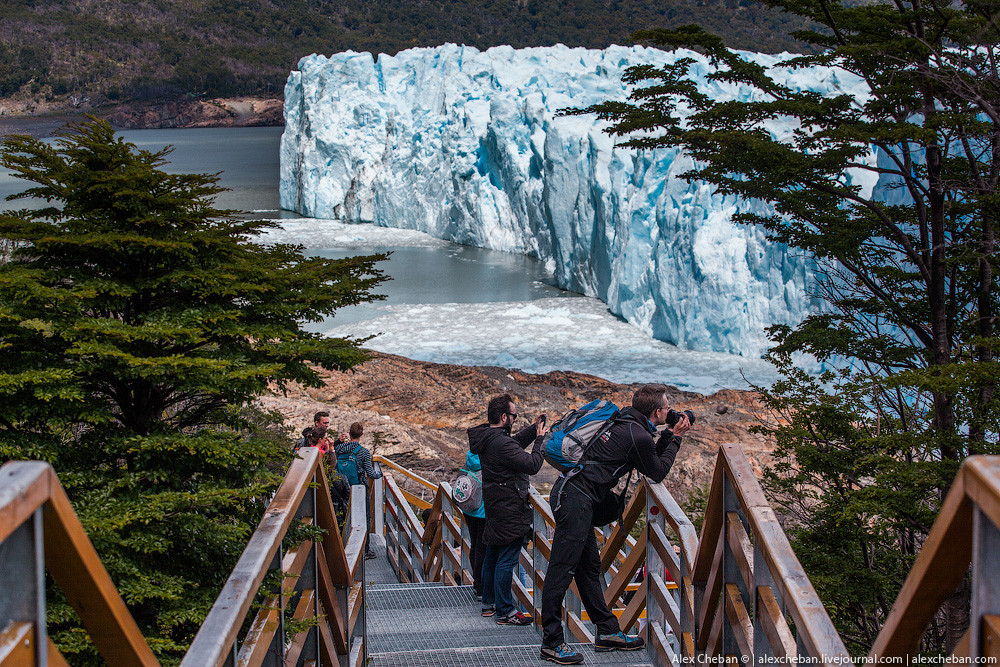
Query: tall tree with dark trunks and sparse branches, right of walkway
584 0 1000 650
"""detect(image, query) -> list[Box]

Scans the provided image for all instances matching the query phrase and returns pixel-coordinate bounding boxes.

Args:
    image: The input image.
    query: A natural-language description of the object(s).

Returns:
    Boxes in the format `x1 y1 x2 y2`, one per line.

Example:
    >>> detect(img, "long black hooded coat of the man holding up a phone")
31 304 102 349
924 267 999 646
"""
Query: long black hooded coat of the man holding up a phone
468 424 542 546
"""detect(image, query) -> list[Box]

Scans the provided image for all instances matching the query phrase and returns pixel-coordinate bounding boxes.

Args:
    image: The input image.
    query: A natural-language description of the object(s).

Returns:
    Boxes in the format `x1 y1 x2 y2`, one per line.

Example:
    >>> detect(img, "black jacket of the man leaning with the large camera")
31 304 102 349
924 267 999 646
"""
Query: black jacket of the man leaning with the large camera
570 406 681 500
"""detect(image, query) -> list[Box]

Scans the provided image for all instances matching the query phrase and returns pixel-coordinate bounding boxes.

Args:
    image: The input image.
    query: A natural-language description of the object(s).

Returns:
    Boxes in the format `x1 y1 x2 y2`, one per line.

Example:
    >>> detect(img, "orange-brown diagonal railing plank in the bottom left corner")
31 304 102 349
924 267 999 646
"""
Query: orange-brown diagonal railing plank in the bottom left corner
42 468 160 666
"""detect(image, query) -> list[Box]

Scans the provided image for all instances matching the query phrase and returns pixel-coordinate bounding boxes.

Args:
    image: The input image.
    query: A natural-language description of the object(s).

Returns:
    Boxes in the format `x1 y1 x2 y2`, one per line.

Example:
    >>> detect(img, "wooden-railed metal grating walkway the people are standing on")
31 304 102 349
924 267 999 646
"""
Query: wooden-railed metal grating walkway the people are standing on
0 445 1000 667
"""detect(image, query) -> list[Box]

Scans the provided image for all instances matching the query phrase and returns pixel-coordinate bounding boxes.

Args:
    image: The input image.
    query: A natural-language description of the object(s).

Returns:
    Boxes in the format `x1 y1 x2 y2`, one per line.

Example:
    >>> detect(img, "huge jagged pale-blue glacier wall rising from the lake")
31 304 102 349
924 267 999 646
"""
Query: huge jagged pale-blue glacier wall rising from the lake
280 44 875 357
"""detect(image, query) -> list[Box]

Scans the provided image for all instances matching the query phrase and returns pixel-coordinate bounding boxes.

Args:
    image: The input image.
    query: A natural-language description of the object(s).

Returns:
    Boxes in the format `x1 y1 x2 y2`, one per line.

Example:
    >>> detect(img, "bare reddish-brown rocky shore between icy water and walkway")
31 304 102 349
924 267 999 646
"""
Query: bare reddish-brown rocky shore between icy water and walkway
260 352 773 502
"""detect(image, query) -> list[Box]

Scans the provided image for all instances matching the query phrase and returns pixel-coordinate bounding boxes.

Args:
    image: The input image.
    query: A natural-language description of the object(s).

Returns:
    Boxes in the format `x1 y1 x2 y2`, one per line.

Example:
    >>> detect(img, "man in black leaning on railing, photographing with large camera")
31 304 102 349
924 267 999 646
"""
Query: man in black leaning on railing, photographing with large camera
541 384 691 665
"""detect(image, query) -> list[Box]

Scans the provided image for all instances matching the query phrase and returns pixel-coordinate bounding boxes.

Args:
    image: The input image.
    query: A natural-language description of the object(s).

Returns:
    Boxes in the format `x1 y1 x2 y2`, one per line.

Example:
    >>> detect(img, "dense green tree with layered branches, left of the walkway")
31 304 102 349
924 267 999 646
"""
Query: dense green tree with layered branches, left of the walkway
0 120 385 664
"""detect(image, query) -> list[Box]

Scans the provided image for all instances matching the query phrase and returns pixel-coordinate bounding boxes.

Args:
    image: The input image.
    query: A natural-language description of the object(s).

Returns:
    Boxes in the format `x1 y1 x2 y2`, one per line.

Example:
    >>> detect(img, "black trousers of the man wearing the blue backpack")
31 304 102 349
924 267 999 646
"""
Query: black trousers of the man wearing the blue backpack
542 479 620 646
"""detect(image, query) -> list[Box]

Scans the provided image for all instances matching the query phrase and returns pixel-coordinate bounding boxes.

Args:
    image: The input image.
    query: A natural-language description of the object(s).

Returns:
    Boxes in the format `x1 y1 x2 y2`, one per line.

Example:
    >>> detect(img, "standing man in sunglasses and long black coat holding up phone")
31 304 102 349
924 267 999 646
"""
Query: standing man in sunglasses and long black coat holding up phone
468 394 545 625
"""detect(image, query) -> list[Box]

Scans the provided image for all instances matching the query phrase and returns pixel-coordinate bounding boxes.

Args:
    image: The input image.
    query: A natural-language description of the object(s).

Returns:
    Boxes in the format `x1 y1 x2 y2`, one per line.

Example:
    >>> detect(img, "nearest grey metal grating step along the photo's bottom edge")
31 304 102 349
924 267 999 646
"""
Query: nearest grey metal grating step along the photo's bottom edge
368 642 652 667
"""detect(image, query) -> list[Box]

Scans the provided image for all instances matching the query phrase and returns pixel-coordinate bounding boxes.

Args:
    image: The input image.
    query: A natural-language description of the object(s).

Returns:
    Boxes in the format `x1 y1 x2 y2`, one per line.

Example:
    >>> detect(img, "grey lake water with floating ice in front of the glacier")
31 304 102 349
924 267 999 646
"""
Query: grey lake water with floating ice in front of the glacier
0 121 776 393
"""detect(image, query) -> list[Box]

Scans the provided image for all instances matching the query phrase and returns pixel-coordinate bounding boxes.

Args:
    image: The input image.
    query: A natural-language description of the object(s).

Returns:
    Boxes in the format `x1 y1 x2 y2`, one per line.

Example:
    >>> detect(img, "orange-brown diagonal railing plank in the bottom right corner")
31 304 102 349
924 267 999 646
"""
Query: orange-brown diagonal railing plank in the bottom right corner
872 464 973 657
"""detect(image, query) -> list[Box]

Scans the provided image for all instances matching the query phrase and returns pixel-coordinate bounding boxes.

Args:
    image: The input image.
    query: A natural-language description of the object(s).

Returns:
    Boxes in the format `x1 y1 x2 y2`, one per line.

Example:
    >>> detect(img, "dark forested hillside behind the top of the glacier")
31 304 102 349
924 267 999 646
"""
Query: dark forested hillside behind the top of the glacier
0 0 801 111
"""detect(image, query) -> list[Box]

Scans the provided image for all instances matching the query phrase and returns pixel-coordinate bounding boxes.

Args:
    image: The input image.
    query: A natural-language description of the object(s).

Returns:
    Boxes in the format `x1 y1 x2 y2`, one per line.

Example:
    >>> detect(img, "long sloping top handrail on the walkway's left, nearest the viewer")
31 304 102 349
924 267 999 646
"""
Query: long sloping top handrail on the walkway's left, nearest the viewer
183 447 323 667
